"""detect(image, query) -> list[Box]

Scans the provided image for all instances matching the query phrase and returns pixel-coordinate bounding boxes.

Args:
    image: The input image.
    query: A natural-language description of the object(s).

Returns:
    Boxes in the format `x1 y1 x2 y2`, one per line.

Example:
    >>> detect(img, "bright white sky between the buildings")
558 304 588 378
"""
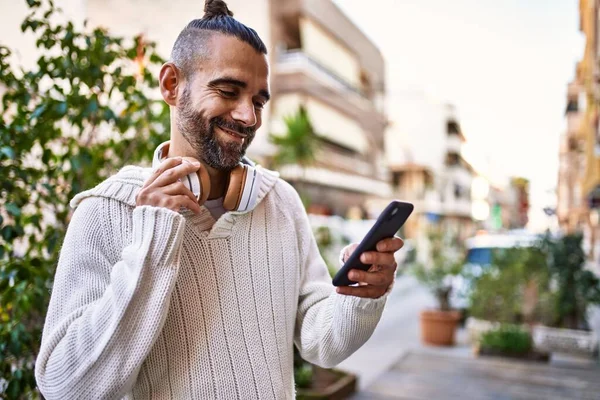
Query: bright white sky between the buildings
334 0 585 230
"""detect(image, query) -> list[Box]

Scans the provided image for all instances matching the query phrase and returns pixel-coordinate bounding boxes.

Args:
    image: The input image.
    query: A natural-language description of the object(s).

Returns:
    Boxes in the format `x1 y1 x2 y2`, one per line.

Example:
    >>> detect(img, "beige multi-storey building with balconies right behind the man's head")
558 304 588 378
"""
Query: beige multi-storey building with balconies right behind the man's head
269 0 391 217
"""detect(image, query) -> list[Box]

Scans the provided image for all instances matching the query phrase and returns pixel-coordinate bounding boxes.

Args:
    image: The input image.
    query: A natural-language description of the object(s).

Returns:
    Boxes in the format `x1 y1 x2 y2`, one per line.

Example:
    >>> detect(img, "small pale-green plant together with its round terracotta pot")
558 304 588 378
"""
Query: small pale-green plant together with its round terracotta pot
412 231 462 346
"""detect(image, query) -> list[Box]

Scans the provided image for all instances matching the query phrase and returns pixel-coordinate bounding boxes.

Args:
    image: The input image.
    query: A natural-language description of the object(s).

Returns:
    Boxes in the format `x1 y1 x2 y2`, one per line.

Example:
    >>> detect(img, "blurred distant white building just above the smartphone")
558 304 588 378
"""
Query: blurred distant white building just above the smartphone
386 92 478 261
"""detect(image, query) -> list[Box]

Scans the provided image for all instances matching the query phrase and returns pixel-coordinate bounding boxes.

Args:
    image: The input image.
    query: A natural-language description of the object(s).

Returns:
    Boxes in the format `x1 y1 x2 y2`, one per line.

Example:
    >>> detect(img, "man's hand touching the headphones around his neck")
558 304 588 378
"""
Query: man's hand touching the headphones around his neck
136 157 200 214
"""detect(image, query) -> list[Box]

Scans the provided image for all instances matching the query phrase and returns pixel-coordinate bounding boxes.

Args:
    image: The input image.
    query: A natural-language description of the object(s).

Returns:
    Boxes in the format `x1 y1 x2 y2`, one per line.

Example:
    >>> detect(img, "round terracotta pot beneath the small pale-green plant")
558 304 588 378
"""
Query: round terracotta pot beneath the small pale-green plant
421 310 460 346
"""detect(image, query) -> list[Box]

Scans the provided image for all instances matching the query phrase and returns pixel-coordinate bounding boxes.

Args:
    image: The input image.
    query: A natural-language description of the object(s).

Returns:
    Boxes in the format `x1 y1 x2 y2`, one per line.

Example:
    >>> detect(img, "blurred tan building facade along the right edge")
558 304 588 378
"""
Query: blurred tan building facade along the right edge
556 0 600 272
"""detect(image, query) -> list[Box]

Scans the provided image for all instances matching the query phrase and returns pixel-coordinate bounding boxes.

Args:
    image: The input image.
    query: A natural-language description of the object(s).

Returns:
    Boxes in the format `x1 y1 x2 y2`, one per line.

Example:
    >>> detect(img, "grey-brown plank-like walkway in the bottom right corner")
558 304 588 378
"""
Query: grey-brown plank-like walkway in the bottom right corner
352 349 600 400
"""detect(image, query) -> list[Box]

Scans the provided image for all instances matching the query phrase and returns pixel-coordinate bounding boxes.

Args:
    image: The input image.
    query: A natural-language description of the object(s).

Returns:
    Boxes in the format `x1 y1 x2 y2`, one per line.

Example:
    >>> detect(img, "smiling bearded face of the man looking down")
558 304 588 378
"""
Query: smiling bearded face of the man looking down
176 34 269 170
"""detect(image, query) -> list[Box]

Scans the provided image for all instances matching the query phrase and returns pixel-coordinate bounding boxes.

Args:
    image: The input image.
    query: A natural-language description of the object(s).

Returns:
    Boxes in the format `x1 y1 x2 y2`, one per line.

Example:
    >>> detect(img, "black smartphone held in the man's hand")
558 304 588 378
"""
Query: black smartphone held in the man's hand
333 200 414 286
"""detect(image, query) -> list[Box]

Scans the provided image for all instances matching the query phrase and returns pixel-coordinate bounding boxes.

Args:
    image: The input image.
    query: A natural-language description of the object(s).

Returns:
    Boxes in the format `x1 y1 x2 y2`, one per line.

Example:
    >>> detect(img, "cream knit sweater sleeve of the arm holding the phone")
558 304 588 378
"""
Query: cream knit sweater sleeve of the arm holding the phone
294 189 387 368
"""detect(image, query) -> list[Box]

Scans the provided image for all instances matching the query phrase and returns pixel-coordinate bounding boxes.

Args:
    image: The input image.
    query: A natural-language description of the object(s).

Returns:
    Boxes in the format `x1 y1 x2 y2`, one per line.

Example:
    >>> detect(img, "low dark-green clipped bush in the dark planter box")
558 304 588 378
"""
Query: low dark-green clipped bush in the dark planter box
480 324 533 354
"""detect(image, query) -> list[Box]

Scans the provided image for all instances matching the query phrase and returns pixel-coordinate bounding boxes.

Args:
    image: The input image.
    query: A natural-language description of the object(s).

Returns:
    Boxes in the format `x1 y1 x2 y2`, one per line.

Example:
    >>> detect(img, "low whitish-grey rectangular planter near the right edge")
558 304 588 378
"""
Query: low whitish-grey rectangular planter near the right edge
532 325 598 357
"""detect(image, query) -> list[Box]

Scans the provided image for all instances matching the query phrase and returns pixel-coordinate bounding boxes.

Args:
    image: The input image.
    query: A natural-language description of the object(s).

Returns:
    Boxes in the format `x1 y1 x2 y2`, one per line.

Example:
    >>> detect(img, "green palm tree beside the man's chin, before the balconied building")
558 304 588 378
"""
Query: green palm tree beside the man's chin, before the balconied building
269 105 319 204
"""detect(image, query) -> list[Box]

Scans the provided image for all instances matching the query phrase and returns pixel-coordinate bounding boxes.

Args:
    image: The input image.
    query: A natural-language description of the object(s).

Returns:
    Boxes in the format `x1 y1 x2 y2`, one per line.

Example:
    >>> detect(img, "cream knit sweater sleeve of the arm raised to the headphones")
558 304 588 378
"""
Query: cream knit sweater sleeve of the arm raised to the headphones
35 197 185 399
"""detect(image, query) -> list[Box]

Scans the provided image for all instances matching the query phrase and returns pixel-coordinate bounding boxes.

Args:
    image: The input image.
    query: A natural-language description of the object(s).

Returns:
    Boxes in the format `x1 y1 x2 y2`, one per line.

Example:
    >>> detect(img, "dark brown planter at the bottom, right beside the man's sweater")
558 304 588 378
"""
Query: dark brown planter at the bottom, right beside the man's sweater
296 366 356 400
